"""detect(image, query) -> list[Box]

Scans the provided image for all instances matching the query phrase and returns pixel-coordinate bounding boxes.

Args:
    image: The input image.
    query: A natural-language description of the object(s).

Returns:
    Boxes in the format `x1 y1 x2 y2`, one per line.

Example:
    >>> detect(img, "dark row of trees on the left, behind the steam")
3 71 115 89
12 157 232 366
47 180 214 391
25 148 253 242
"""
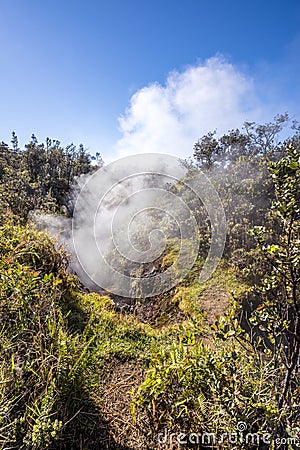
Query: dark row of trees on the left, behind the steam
0 133 98 219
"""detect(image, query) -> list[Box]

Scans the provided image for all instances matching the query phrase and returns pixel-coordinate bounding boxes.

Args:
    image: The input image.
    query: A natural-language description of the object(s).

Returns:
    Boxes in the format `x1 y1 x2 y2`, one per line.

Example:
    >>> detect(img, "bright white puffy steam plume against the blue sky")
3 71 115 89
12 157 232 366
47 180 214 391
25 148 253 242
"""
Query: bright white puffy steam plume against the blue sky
116 57 264 156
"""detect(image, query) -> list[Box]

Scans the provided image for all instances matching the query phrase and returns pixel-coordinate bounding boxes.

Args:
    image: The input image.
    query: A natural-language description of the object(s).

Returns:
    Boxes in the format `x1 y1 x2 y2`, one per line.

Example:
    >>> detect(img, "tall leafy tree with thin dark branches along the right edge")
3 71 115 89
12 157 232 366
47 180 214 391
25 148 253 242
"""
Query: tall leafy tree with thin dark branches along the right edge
252 145 300 448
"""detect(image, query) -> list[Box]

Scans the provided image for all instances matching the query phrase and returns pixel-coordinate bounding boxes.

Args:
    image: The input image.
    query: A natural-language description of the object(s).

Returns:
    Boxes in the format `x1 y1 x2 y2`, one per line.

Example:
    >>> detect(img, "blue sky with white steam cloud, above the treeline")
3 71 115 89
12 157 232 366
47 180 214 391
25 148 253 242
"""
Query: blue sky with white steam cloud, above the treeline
0 0 300 161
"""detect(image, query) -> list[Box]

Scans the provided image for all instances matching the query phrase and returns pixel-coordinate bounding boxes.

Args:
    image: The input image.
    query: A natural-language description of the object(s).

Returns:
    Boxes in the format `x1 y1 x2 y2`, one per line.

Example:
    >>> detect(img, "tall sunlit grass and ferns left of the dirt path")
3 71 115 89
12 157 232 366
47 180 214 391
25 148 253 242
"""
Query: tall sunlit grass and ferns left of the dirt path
0 225 98 449
